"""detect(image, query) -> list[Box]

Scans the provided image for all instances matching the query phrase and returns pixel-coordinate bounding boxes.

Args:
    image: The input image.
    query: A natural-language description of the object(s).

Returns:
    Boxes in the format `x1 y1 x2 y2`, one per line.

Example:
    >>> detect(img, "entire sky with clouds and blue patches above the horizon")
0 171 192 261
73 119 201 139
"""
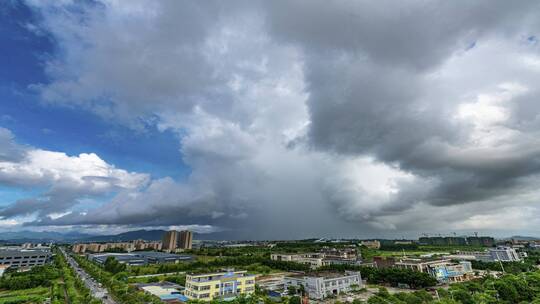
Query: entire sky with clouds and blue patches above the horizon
0 0 540 239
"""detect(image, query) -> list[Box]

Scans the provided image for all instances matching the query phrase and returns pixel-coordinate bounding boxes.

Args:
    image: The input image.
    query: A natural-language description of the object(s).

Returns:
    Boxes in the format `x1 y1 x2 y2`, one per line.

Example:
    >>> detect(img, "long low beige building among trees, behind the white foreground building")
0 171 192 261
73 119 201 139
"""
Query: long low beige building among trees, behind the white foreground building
270 248 362 269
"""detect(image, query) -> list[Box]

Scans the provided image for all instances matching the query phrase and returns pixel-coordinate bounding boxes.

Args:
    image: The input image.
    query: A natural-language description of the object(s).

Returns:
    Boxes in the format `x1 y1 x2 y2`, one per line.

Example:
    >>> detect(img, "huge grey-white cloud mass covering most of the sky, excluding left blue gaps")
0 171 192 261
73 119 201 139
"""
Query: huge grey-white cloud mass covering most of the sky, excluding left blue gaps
9 0 540 238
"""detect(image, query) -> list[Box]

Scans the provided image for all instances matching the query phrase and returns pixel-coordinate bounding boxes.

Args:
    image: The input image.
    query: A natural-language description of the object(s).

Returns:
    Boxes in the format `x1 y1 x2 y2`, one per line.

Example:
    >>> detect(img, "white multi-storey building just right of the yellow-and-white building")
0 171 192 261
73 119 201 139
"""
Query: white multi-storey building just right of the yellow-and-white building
283 271 363 299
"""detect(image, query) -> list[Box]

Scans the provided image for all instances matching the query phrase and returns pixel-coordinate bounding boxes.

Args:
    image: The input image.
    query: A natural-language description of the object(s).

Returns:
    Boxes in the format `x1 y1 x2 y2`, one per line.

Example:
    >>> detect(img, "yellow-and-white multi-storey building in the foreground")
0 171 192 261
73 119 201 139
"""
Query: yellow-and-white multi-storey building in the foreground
184 270 255 301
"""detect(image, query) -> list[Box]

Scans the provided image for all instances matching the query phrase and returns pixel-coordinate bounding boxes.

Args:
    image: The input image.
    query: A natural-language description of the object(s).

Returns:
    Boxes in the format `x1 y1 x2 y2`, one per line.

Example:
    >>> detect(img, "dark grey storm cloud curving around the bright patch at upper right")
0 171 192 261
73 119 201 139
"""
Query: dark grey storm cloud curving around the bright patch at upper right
260 1 540 216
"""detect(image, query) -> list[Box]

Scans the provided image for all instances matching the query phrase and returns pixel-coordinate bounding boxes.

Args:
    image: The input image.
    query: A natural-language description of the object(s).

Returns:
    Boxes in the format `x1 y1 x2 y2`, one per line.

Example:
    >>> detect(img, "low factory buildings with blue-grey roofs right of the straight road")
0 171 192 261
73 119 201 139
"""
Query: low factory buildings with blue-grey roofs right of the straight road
87 251 193 266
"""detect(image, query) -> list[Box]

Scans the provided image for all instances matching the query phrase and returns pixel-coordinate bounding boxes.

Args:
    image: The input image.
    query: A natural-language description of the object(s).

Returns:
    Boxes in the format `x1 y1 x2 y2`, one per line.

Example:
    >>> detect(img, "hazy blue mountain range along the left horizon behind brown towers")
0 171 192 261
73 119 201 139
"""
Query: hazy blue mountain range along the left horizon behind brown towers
0 229 234 243
